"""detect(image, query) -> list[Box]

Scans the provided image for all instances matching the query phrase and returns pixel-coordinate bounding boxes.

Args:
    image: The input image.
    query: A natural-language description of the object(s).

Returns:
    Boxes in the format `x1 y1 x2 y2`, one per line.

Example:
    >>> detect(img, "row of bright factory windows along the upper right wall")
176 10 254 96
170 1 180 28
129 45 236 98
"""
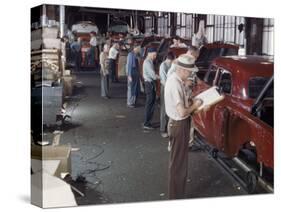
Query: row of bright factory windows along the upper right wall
145 12 274 55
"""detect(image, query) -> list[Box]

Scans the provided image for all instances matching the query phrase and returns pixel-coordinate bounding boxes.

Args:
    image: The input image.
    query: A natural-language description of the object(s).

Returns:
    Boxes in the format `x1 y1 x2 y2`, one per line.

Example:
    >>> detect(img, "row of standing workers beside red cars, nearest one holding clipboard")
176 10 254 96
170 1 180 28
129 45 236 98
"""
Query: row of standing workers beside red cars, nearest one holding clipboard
97 38 208 199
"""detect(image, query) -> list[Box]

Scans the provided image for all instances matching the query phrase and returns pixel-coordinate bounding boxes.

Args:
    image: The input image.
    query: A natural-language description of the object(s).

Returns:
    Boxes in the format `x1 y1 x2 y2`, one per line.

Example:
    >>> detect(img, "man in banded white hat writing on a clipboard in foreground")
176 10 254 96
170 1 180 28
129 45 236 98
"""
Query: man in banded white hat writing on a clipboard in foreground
165 55 202 199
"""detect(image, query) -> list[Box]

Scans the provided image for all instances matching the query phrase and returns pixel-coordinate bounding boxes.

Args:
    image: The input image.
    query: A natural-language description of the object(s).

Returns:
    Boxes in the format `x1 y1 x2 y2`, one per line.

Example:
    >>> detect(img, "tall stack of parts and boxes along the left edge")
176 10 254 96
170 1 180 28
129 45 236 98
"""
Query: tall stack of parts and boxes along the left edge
31 27 73 126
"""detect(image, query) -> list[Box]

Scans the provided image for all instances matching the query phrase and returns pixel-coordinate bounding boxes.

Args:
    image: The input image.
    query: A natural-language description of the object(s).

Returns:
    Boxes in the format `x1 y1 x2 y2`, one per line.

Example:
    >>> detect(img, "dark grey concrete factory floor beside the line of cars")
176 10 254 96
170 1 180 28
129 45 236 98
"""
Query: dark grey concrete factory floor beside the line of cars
60 73 247 205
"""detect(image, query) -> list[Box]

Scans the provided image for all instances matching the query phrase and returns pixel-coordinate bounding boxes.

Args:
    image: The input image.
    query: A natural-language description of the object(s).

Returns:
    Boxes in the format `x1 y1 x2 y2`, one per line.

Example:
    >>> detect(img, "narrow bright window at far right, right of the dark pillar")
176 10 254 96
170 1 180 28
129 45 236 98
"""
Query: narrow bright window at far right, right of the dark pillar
262 18 274 55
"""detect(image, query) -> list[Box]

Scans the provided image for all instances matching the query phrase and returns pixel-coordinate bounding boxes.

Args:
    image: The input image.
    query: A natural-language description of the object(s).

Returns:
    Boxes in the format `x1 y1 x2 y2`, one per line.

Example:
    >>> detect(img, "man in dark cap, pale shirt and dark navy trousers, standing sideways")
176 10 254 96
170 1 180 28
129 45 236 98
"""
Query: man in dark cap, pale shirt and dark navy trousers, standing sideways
143 48 159 130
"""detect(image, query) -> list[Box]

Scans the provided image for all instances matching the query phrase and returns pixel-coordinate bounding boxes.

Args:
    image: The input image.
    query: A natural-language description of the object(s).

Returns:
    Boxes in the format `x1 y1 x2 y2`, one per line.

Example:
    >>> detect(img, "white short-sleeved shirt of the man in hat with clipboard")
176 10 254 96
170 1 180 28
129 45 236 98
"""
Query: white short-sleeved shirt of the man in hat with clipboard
164 72 190 121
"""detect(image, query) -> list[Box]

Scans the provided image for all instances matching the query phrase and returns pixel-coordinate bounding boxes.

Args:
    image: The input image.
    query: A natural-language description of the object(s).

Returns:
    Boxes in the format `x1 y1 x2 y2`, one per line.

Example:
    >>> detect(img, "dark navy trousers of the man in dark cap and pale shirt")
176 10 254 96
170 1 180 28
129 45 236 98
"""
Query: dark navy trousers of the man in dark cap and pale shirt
144 82 156 126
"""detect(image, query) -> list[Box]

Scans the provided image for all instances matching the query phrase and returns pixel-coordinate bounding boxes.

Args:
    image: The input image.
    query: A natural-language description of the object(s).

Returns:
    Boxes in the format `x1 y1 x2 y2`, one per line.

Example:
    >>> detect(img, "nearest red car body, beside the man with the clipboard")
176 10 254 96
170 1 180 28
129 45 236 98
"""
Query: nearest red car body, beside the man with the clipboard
193 56 274 169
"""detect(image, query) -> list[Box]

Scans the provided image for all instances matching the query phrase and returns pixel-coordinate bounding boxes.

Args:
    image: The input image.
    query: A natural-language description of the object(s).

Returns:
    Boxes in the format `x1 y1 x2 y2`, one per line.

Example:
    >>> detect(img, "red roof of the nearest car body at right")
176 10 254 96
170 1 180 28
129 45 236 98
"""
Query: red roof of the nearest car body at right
213 55 274 76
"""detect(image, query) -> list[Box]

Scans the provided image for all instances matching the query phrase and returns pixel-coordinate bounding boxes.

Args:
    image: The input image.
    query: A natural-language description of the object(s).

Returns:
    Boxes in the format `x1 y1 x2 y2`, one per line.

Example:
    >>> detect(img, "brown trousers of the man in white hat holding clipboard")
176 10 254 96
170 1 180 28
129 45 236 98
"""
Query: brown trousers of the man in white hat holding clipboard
168 118 190 199
